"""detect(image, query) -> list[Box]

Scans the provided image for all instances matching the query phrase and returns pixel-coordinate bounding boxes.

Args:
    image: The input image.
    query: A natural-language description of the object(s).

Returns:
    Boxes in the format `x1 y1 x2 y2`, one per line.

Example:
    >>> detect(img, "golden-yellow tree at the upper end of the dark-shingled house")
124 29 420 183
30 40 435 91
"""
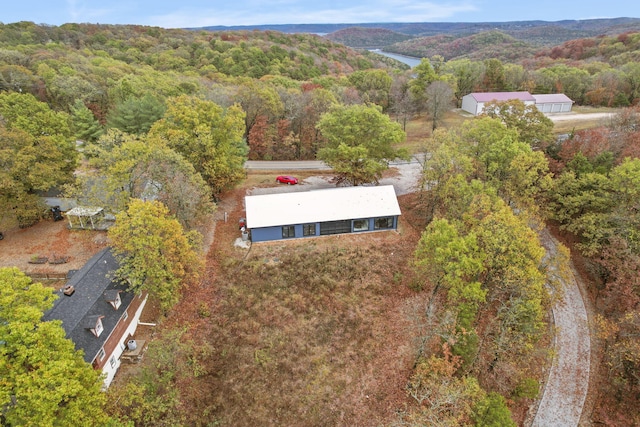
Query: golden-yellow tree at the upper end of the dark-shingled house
108 199 202 312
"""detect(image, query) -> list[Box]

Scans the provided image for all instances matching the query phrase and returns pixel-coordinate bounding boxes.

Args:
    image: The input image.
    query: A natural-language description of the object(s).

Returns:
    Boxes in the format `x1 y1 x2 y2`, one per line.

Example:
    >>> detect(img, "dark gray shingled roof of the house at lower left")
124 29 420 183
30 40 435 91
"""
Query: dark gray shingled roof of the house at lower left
43 248 135 363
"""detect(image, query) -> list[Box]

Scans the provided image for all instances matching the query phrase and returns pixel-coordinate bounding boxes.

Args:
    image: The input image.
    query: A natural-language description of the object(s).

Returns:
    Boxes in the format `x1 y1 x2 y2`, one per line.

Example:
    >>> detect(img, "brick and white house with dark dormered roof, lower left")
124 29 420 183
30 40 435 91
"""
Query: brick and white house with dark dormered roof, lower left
43 248 147 388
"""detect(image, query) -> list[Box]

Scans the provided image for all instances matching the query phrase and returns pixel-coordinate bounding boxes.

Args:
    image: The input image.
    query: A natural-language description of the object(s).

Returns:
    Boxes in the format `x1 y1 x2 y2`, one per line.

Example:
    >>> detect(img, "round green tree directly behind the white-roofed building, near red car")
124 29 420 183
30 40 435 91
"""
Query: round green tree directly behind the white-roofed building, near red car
318 105 406 185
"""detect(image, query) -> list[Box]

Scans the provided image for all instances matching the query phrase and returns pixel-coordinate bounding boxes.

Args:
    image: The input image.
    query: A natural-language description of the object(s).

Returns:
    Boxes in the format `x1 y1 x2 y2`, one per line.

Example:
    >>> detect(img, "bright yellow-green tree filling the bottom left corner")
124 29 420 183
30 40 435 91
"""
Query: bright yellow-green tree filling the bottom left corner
0 268 110 427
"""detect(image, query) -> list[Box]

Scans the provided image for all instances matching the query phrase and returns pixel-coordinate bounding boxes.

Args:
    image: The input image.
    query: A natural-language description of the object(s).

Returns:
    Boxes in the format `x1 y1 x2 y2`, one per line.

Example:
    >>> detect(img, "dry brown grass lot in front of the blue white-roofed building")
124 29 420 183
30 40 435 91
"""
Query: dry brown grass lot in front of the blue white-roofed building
141 186 430 426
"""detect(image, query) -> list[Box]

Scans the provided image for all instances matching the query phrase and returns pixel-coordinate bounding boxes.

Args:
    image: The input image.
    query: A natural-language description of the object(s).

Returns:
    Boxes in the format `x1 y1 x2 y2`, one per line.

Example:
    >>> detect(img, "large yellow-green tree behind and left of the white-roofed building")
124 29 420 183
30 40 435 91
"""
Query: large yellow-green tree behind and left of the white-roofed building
149 95 247 195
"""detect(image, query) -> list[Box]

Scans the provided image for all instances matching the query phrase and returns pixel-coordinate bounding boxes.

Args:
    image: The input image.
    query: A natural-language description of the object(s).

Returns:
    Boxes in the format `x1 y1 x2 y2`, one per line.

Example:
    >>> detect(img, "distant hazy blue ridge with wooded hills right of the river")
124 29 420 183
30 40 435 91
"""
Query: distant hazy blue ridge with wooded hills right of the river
192 18 640 63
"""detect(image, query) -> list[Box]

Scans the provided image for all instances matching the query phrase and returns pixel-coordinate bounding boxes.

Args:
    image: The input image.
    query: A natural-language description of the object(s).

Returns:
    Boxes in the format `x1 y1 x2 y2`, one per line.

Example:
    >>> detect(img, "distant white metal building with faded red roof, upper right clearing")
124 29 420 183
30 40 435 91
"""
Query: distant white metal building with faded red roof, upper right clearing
462 91 573 116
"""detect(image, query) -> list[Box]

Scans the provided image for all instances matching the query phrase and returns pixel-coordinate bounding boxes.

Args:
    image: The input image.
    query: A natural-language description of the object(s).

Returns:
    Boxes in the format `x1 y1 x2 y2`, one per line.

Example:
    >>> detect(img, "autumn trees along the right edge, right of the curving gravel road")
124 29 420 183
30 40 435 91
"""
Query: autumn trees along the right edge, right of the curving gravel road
548 106 640 425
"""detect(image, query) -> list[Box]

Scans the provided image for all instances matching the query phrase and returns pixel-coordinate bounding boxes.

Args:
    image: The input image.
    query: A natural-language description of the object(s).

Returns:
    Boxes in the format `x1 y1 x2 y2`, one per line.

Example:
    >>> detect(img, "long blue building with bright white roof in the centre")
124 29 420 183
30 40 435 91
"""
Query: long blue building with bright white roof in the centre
245 185 400 242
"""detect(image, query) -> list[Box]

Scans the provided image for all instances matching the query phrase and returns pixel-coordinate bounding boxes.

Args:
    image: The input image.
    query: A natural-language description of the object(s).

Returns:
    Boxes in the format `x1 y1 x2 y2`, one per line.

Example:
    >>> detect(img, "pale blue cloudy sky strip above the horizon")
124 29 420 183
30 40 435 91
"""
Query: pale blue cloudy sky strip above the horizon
0 0 640 28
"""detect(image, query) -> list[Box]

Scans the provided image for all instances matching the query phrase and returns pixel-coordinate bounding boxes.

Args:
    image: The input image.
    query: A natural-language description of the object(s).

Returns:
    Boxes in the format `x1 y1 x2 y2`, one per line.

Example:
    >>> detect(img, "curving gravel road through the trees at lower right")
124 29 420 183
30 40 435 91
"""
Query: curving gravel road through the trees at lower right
531 229 591 427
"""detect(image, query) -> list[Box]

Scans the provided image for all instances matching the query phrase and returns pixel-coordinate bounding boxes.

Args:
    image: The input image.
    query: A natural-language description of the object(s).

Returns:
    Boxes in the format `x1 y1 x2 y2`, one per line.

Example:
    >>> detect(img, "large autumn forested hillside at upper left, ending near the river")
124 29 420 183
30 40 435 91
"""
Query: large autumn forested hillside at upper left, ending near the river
0 22 396 117
